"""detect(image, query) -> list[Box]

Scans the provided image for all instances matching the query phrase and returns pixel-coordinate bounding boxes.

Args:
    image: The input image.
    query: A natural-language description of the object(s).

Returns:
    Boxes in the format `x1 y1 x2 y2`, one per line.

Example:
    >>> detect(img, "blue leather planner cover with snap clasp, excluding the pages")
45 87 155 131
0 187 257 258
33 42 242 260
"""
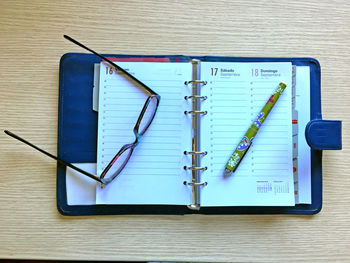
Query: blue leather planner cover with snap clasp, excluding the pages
57 53 341 216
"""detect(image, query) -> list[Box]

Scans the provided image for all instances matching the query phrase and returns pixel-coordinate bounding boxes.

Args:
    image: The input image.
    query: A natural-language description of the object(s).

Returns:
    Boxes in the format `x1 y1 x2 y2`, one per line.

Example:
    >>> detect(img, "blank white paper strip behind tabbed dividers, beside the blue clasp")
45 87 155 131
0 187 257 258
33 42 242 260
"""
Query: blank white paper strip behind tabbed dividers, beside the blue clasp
295 67 311 204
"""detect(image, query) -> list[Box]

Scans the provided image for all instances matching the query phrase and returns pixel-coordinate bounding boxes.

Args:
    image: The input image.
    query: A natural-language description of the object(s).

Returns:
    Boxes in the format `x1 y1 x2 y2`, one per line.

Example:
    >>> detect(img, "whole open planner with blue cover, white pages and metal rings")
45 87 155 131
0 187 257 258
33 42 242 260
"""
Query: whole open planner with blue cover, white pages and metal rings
57 53 340 215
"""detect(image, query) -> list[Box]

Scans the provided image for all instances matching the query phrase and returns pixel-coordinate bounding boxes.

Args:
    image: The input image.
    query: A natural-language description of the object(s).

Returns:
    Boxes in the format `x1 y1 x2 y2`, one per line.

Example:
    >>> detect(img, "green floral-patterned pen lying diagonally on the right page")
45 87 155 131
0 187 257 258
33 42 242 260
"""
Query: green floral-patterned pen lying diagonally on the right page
224 82 287 176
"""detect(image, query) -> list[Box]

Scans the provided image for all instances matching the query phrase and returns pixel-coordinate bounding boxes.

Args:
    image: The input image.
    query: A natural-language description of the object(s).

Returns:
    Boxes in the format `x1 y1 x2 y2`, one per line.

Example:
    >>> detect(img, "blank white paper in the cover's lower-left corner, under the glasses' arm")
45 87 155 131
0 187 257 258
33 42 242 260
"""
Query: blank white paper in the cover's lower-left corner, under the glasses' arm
66 163 96 205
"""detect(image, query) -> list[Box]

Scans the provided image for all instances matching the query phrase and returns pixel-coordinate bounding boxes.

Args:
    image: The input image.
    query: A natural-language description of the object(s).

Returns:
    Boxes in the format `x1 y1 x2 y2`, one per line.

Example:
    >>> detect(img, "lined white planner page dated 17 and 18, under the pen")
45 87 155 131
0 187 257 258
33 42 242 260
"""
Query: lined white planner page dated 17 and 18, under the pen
201 62 295 206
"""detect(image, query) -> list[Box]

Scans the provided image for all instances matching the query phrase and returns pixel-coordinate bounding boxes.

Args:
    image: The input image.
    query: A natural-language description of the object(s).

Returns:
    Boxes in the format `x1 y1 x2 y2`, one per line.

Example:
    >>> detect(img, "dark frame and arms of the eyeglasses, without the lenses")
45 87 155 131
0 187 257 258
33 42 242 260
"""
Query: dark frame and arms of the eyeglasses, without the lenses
4 35 160 185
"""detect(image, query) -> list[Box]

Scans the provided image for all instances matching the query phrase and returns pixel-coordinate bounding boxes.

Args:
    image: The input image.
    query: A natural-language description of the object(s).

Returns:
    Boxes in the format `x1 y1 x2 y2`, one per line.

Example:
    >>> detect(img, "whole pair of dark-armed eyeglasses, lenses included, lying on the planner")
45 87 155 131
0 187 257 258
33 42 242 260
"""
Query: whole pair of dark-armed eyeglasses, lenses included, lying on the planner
4 35 160 185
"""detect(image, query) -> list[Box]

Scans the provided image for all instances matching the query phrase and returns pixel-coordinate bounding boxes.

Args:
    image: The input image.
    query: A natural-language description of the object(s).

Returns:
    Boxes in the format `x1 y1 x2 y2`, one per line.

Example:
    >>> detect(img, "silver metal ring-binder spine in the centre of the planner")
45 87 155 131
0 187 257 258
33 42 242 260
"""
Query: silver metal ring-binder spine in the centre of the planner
184 59 207 210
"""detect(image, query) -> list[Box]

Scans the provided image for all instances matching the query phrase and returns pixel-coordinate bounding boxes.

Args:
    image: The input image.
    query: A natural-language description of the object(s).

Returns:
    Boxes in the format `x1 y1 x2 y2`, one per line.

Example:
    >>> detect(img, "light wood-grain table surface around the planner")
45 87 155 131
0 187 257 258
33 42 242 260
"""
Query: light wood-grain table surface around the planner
0 0 350 262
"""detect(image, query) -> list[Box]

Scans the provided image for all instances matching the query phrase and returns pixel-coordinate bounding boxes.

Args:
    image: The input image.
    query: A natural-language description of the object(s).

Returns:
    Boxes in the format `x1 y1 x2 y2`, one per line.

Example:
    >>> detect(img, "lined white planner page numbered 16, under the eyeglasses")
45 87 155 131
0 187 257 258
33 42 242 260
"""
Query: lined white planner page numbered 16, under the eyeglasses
96 62 192 205
